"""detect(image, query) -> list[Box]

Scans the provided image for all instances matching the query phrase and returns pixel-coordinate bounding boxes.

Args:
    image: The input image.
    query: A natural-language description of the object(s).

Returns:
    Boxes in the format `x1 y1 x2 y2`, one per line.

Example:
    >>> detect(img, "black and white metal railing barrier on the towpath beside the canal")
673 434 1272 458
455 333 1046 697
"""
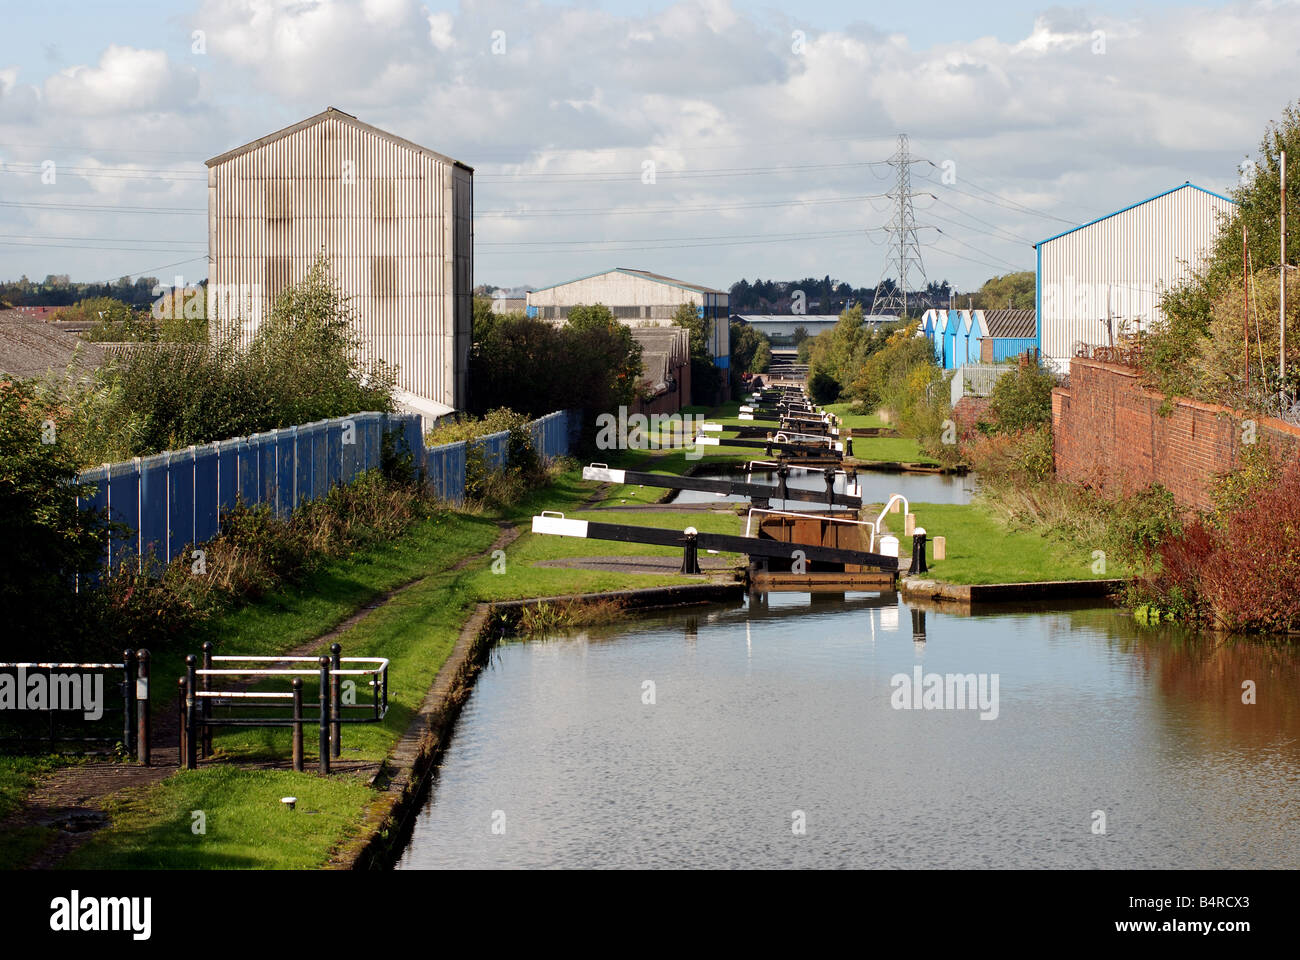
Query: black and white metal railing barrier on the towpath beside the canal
177 643 389 775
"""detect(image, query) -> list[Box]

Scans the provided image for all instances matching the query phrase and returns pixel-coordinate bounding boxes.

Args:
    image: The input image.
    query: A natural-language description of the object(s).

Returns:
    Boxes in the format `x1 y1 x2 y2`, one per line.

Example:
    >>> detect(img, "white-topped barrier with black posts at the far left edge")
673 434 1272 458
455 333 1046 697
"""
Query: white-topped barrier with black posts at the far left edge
0 649 150 766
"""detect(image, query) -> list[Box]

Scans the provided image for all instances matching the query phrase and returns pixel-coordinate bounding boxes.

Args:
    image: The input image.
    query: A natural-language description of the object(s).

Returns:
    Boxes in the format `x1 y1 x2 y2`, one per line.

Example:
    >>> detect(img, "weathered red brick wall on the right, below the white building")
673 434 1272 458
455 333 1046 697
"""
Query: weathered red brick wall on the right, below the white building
1052 358 1300 509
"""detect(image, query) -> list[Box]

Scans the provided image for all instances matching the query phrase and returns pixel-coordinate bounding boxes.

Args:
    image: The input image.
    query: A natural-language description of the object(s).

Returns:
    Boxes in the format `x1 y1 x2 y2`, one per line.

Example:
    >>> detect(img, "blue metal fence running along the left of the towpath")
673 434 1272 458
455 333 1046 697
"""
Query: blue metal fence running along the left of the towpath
78 411 581 570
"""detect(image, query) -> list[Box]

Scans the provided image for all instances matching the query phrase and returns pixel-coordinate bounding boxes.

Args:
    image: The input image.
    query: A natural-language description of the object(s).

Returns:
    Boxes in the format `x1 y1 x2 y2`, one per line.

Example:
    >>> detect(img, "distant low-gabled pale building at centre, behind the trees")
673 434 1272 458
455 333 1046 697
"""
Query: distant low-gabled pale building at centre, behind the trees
528 267 731 369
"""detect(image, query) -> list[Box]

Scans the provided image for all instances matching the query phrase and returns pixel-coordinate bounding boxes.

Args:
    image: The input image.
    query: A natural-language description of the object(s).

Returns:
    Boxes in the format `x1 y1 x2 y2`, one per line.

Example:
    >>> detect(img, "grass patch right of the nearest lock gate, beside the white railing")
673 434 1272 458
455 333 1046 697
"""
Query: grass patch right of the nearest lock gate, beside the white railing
887 503 1128 584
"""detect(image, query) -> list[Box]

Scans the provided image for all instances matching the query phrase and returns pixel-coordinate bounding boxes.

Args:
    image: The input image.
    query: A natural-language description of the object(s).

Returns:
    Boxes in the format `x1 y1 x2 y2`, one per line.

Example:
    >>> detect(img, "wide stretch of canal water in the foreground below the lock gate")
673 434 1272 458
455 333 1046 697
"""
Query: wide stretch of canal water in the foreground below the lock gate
399 593 1300 869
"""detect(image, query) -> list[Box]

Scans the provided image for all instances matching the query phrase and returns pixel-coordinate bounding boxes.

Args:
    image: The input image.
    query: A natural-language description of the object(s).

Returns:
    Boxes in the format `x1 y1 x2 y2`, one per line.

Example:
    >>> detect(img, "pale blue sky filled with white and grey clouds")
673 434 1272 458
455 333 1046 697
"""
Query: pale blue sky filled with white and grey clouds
0 0 1300 290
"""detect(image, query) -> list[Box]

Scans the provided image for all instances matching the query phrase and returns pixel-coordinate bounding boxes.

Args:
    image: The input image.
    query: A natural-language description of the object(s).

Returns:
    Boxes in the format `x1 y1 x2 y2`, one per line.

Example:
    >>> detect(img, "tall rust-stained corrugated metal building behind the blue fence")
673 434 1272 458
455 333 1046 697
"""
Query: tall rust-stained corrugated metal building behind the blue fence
200 107 473 414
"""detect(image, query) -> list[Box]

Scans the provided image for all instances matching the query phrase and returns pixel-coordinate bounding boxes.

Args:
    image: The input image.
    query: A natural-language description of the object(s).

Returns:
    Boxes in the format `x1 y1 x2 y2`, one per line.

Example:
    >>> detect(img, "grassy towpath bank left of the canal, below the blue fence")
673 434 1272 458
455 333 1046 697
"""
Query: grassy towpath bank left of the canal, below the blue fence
25 460 742 869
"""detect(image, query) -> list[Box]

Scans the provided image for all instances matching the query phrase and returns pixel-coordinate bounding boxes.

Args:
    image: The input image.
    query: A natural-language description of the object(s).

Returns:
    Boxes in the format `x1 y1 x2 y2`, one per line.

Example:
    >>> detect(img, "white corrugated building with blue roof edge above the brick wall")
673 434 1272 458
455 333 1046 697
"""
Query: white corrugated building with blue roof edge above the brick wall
1035 183 1235 372
